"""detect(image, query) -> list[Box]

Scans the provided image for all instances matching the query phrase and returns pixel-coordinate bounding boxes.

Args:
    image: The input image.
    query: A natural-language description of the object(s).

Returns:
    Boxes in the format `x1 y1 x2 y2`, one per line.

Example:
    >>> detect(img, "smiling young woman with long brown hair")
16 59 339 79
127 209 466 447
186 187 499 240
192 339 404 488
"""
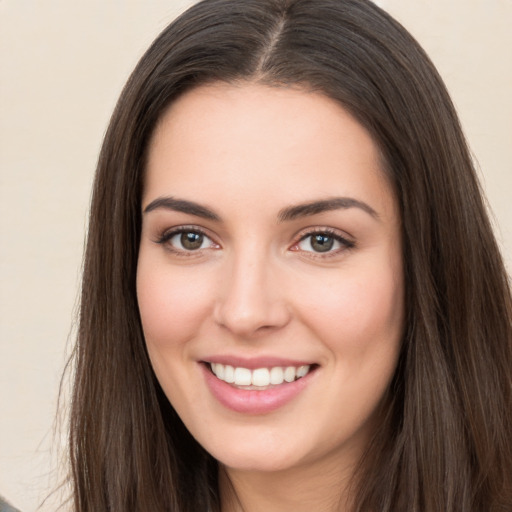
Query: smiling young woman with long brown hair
70 0 512 512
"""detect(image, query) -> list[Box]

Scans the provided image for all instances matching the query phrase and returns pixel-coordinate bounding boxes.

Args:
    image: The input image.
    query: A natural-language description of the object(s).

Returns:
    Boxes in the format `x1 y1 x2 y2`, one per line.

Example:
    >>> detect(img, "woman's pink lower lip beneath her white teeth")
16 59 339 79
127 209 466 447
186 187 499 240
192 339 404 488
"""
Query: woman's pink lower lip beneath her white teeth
201 363 315 414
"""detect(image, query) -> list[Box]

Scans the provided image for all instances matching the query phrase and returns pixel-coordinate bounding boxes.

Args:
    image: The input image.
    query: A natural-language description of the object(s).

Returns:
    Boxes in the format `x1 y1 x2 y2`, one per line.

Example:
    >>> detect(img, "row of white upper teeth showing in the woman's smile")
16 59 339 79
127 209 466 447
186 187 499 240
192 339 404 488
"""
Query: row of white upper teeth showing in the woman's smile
210 363 310 388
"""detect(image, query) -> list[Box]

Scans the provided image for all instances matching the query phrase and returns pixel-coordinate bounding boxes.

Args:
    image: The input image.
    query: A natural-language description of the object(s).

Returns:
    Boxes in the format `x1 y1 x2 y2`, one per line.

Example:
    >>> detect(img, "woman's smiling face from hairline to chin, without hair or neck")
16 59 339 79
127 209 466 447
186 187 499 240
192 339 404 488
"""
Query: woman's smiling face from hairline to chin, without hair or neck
137 84 404 471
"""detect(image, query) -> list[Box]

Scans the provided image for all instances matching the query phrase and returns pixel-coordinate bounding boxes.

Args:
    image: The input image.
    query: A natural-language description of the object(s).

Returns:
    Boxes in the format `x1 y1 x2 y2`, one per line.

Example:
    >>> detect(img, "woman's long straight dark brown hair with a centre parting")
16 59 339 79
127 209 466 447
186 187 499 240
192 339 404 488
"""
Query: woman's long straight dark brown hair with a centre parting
69 0 512 512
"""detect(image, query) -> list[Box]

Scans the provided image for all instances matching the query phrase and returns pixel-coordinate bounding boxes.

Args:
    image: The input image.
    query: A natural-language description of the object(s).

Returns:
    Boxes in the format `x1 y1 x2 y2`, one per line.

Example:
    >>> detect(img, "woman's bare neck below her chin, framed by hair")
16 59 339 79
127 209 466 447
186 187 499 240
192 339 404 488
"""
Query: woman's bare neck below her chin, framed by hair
219 456 353 512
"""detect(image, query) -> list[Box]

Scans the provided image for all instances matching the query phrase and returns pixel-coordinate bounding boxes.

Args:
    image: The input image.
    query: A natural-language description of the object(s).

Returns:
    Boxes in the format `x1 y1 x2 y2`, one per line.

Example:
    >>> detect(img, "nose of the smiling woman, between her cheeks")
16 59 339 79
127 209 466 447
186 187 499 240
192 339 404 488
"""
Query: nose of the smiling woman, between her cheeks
214 250 291 338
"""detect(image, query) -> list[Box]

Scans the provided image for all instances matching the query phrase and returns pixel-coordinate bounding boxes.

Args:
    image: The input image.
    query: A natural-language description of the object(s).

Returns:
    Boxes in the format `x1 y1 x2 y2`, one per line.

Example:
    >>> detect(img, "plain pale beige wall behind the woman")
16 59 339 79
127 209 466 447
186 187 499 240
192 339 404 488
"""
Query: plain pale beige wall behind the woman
0 0 512 512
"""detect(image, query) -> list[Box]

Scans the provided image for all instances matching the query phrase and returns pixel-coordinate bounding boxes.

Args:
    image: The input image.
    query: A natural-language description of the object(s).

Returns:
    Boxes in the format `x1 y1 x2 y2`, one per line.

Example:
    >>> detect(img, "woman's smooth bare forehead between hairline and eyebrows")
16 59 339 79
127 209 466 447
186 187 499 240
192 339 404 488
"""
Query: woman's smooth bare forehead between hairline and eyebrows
144 83 391 220
